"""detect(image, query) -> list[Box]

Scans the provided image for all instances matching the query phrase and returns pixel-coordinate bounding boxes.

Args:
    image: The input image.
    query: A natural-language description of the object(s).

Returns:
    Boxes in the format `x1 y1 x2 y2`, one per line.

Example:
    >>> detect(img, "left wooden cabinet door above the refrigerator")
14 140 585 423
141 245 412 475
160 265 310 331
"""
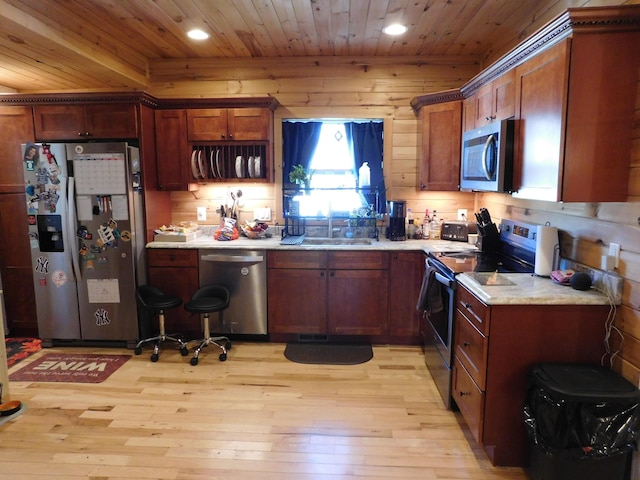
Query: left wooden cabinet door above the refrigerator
33 105 87 140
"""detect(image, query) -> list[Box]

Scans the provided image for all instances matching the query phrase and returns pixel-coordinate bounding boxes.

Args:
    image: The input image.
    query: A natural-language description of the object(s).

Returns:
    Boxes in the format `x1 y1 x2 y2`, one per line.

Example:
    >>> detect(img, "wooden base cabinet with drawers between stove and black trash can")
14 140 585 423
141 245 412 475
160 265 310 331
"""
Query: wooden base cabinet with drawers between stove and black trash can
452 283 609 466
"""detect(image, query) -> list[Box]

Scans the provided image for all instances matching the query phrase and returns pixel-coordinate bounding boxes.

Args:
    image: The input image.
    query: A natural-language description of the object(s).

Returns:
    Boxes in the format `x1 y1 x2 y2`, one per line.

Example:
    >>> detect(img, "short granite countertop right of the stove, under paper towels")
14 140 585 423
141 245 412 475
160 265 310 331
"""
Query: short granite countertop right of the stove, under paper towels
456 273 609 305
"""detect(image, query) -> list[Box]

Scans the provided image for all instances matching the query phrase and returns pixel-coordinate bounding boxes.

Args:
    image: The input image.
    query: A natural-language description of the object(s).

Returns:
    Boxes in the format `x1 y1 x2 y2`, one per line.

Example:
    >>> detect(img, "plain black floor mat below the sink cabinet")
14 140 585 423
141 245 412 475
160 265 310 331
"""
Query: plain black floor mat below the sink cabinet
284 343 373 365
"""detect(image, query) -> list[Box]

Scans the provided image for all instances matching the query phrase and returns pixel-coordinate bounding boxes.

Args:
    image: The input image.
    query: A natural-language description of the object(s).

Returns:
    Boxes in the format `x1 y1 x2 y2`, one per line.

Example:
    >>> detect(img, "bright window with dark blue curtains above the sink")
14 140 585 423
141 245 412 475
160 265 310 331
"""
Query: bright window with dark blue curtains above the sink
283 120 384 217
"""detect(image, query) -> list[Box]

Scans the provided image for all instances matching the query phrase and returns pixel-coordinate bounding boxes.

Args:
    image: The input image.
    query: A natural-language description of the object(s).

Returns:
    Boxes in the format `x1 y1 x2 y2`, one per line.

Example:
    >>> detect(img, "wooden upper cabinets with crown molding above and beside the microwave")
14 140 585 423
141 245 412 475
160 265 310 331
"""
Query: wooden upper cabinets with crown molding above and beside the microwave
461 5 640 202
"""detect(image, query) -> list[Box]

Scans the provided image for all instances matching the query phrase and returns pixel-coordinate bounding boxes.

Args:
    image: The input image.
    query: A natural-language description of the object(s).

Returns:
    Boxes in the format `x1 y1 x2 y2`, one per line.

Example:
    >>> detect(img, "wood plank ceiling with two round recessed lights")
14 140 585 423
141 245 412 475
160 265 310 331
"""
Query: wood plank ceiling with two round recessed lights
0 0 636 93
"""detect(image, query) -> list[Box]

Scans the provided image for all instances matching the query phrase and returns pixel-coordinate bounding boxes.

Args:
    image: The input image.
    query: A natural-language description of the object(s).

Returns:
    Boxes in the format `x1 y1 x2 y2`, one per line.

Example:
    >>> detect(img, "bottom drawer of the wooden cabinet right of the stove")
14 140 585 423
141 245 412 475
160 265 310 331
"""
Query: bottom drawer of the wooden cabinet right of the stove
452 357 484 444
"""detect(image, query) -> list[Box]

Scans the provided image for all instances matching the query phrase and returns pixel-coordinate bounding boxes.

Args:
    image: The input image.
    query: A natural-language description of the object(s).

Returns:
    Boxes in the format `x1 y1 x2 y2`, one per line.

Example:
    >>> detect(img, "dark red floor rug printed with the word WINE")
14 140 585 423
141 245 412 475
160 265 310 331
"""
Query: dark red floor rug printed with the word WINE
9 353 131 383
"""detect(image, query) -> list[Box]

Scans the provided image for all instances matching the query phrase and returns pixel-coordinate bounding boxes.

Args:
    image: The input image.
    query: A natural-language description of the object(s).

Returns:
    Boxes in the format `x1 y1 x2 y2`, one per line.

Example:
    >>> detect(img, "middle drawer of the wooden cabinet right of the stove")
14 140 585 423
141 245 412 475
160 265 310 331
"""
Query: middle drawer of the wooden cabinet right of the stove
454 310 489 390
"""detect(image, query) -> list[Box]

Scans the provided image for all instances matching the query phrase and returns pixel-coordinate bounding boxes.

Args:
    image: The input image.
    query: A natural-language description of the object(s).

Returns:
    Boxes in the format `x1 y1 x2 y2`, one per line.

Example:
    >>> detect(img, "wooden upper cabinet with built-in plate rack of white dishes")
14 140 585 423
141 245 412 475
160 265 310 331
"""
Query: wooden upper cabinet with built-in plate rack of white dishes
156 97 278 190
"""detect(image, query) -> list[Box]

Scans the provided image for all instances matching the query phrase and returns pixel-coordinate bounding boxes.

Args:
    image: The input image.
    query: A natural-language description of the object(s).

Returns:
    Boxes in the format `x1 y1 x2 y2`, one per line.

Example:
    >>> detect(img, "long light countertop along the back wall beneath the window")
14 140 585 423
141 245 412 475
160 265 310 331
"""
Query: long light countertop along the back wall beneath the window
146 235 476 253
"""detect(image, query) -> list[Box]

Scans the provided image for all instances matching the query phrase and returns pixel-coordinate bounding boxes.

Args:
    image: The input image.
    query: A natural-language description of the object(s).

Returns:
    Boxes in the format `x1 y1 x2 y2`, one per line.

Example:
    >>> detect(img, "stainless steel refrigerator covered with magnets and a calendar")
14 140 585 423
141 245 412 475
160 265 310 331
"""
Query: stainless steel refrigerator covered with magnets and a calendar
22 143 144 346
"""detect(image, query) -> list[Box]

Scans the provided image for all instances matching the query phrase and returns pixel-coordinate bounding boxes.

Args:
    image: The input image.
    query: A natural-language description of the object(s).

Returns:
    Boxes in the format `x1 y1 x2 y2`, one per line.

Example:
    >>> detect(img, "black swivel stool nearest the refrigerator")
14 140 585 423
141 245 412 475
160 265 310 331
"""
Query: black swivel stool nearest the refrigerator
134 285 189 362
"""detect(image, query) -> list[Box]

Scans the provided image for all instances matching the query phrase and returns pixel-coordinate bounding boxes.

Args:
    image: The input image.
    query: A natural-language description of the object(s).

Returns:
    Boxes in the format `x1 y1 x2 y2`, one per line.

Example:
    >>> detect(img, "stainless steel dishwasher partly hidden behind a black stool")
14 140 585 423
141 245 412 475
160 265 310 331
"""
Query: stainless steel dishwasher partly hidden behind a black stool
198 249 267 340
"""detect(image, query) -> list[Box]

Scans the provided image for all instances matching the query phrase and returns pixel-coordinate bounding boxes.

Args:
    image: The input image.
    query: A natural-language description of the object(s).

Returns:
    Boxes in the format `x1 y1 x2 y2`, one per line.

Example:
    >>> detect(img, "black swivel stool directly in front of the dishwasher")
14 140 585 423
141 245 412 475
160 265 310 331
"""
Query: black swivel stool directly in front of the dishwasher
184 284 231 365
